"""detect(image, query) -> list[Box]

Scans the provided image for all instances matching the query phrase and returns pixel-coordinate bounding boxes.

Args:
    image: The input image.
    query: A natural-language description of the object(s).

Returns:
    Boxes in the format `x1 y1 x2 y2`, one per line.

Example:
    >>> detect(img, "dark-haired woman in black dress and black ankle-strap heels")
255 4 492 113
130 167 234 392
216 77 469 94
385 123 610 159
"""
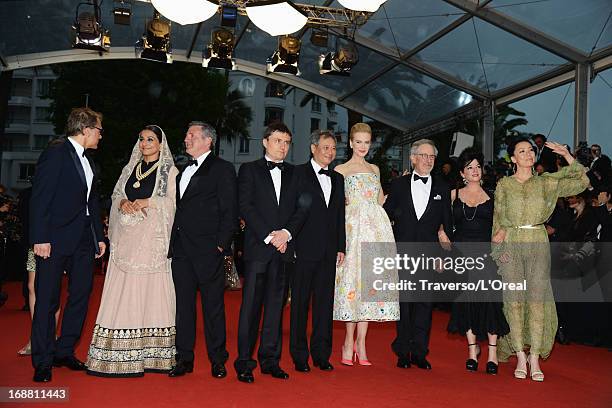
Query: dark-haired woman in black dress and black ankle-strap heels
448 149 510 374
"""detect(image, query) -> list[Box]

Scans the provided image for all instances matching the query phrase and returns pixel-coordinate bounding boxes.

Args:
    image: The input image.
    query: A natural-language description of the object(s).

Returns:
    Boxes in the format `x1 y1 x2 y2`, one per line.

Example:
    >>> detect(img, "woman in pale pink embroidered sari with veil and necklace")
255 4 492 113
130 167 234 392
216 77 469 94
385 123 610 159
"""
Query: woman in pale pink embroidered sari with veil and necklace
87 125 178 377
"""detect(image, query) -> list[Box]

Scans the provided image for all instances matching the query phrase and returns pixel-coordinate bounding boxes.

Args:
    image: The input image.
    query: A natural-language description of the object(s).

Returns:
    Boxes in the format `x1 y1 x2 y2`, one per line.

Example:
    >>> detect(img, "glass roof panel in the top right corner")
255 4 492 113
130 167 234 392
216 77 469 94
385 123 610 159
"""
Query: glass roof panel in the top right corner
488 0 612 53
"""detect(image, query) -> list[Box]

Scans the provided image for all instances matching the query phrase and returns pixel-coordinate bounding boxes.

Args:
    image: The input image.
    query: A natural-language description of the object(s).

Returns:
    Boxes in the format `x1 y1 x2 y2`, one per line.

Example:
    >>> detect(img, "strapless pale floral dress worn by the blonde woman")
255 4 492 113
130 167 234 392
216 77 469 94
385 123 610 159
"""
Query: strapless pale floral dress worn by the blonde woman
334 173 400 322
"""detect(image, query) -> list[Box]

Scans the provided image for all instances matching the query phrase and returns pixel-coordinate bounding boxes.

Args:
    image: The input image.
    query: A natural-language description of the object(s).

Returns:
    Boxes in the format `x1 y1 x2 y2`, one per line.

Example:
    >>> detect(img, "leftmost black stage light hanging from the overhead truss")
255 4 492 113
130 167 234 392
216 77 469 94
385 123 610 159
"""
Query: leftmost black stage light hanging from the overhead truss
72 1 110 52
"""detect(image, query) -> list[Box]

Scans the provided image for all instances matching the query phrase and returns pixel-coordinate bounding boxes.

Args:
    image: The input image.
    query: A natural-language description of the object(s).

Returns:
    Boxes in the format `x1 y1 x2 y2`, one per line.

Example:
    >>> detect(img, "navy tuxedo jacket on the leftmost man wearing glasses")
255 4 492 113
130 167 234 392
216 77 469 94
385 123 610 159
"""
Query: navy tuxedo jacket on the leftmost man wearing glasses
29 140 104 255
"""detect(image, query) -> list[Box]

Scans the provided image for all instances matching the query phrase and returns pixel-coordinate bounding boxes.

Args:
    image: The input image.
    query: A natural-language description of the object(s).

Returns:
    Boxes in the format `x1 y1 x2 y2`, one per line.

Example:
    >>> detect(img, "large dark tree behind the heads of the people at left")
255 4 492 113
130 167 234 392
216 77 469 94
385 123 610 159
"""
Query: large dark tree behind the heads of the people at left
51 60 250 194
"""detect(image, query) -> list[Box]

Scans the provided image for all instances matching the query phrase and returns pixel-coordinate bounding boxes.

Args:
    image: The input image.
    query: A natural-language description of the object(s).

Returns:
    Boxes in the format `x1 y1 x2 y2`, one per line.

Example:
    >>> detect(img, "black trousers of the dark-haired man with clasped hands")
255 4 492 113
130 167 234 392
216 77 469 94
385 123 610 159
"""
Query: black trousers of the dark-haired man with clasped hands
234 254 288 373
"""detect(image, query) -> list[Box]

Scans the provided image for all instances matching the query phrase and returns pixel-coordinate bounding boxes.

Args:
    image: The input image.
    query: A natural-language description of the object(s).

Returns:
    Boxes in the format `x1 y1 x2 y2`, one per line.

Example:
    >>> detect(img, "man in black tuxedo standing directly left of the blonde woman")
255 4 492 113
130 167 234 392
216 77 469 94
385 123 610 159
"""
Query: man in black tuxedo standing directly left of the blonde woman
289 130 346 372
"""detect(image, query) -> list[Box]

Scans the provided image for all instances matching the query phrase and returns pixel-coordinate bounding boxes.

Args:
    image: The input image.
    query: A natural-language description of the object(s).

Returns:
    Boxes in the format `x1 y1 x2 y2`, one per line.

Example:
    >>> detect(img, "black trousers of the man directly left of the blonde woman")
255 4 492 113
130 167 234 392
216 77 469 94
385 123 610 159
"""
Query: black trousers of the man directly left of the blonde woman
289 254 336 364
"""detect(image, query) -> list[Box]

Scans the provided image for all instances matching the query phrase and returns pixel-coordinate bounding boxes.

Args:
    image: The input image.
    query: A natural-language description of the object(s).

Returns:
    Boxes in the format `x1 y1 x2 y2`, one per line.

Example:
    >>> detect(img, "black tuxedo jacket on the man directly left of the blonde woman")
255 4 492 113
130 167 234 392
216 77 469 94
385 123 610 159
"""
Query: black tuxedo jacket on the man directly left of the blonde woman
295 160 346 262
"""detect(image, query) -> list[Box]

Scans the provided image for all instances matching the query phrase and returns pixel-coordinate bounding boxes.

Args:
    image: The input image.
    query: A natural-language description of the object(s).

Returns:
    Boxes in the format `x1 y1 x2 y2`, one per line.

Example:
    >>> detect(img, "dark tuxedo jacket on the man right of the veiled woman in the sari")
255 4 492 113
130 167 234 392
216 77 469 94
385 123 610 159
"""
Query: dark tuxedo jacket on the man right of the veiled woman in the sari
168 153 238 262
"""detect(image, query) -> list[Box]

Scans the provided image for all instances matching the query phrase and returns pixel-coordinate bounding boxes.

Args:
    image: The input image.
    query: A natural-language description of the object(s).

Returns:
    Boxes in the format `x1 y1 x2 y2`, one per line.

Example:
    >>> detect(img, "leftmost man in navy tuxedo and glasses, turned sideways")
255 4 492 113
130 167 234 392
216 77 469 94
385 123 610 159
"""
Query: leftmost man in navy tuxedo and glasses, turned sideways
30 108 106 382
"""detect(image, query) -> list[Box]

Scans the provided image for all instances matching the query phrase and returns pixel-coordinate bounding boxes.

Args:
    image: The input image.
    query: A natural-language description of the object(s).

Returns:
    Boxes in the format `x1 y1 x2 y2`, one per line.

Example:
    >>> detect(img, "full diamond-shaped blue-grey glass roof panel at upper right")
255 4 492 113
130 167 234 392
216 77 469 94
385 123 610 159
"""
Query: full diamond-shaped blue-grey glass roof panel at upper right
416 18 567 92
